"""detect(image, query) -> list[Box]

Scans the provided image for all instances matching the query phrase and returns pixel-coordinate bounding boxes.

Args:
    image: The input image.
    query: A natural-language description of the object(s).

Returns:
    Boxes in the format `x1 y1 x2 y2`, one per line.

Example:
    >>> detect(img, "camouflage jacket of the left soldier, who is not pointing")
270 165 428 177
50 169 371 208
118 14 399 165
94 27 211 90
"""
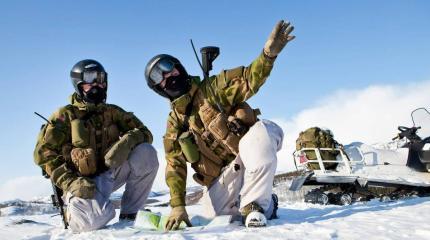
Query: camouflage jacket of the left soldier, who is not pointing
34 93 152 191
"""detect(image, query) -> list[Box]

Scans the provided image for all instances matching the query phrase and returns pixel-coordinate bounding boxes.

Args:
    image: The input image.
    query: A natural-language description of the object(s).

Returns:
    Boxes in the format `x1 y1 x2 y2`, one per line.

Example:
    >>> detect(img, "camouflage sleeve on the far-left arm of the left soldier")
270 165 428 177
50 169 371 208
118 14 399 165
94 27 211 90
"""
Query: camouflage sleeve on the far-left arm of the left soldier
34 109 78 191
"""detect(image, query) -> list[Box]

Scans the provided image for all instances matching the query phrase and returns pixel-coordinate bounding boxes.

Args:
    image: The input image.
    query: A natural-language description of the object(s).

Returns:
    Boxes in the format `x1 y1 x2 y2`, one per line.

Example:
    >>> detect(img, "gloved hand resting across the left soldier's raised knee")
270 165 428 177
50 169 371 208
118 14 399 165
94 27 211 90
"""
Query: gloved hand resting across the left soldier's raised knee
105 129 145 168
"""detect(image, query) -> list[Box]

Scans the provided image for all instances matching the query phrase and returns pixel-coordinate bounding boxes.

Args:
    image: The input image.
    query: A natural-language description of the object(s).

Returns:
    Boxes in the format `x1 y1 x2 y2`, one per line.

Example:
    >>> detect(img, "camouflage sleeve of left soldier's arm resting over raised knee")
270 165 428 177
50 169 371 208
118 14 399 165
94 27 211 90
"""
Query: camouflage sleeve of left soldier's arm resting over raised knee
111 105 153 144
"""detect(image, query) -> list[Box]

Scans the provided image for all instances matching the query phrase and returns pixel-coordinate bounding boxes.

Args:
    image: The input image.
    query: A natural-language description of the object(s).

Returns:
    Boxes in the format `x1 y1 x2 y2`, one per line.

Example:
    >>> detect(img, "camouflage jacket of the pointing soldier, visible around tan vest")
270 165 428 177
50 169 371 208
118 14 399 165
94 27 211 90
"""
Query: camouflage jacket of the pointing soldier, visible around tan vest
163 53 275 207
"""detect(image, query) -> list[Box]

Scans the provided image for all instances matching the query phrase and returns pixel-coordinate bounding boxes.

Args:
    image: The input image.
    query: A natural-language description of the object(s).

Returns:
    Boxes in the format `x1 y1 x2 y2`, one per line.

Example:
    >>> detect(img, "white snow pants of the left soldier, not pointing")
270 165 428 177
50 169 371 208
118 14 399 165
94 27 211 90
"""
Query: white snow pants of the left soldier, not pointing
65 143 158 232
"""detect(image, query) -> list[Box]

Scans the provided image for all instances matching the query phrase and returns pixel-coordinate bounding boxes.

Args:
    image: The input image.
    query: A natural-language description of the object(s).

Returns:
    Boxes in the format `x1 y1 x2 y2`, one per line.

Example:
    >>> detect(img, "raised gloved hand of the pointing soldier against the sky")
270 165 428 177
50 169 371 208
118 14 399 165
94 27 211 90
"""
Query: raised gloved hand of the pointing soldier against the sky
264 20 295 58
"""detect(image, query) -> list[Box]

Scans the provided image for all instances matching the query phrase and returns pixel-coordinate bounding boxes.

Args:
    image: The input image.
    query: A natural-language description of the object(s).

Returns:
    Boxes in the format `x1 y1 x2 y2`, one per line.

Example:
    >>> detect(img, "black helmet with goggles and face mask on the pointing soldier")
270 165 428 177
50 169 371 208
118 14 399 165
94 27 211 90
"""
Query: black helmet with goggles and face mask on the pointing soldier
145 54 191 100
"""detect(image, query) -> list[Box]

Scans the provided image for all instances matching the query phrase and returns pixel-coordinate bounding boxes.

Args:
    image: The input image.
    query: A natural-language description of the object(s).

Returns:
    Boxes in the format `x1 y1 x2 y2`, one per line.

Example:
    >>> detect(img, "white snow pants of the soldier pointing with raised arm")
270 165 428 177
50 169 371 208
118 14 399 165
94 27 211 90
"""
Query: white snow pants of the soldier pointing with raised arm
202 120 284 218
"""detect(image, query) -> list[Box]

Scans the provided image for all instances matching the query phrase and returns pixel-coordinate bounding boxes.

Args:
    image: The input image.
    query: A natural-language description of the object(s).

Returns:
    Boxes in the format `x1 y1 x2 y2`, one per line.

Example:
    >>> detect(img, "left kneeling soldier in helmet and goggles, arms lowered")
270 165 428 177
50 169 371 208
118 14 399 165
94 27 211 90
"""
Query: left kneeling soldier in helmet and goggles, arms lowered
34 60 158 232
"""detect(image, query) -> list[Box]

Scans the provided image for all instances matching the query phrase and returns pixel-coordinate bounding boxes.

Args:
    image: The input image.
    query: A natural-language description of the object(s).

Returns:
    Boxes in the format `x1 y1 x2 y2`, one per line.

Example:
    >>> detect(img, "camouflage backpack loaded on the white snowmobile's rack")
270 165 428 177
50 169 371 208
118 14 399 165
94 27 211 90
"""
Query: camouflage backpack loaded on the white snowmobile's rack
296 127 339 170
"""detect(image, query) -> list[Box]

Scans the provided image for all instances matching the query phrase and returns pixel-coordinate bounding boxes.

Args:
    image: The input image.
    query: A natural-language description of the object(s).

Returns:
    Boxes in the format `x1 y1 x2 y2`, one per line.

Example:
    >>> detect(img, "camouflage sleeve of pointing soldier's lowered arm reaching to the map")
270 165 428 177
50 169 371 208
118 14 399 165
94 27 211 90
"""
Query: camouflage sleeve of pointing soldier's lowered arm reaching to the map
163 112 187 207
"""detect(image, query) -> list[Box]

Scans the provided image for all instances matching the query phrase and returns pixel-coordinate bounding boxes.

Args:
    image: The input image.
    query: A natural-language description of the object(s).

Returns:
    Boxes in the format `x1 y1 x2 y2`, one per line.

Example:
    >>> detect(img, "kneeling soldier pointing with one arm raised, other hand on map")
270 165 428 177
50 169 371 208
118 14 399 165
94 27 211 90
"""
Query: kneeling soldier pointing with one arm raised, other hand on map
145 21 294 229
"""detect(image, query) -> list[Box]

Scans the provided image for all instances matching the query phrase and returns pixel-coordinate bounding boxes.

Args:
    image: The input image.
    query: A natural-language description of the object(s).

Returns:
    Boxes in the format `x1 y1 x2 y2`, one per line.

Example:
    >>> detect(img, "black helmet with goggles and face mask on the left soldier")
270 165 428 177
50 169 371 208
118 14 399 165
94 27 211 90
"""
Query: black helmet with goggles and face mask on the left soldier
70 59 108 103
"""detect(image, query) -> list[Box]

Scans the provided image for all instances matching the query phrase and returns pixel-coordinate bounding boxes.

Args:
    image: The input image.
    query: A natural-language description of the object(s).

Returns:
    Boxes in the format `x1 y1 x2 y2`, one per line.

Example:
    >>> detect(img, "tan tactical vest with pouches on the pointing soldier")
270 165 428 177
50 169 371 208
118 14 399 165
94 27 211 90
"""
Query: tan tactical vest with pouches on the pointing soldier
173 86 260 186
